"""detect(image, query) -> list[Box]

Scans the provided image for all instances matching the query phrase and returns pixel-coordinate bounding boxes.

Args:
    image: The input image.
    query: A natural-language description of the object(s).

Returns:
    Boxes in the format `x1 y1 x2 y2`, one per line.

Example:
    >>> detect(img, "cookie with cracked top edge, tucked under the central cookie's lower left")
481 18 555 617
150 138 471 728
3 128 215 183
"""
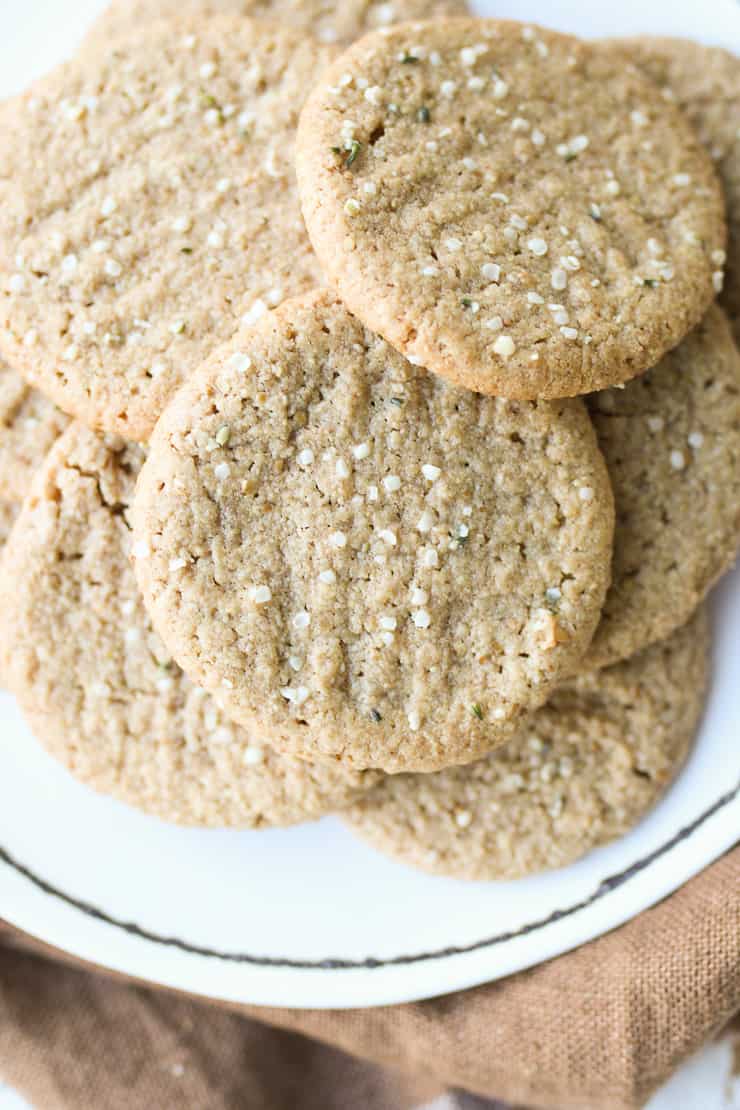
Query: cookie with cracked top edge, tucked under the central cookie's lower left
0 425 377 828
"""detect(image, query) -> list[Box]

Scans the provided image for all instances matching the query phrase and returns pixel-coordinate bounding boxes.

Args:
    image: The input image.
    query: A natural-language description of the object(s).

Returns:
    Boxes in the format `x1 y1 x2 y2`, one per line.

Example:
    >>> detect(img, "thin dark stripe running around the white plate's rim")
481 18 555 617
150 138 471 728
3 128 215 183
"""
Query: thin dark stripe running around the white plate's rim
0 781 740 971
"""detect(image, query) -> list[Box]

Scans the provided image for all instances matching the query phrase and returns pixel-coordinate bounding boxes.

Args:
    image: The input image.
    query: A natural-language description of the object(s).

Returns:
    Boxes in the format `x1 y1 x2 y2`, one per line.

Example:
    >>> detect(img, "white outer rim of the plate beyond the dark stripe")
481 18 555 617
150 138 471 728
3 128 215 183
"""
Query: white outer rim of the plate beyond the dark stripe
0 779 740 1009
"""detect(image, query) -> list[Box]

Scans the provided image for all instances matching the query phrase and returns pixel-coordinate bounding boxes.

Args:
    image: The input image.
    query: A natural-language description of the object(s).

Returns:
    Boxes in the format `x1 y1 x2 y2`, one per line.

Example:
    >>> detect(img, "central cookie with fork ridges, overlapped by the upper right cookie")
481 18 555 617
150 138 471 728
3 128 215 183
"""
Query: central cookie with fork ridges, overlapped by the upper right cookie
133 292 614 771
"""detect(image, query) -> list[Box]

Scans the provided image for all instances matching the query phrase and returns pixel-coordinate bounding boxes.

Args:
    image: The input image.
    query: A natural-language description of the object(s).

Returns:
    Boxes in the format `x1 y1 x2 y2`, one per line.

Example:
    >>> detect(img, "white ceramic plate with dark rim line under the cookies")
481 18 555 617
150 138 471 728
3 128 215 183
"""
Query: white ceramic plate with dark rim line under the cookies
0 0 740 1007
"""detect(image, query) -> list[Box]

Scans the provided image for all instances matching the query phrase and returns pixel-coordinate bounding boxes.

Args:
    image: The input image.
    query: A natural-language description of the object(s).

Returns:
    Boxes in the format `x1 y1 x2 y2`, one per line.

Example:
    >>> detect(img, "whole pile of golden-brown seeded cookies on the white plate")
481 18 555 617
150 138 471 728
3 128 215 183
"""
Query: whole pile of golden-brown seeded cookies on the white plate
0 0 740 879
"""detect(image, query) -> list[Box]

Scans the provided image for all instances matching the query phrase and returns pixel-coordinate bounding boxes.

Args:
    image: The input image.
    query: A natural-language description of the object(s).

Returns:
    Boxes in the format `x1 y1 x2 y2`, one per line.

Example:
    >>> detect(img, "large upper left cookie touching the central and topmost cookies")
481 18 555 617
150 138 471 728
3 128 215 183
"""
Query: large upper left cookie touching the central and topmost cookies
0 17 331 441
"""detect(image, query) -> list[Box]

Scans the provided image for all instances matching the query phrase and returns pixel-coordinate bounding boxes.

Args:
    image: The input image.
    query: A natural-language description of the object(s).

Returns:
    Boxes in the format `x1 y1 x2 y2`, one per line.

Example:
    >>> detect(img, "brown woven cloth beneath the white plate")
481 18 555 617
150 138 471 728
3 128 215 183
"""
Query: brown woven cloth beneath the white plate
0 847 740 1110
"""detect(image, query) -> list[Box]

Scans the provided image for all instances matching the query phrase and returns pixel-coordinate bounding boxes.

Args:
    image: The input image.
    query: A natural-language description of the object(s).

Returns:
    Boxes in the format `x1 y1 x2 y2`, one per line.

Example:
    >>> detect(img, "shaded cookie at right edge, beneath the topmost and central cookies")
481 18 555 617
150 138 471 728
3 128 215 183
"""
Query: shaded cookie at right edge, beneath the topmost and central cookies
587 306 740 667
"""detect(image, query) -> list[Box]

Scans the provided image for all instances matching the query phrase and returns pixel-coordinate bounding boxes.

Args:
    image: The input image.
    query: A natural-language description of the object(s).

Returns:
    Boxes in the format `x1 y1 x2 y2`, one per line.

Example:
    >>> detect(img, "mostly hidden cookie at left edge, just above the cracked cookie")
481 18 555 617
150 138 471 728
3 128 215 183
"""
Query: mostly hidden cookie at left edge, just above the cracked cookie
0 362 69 501
